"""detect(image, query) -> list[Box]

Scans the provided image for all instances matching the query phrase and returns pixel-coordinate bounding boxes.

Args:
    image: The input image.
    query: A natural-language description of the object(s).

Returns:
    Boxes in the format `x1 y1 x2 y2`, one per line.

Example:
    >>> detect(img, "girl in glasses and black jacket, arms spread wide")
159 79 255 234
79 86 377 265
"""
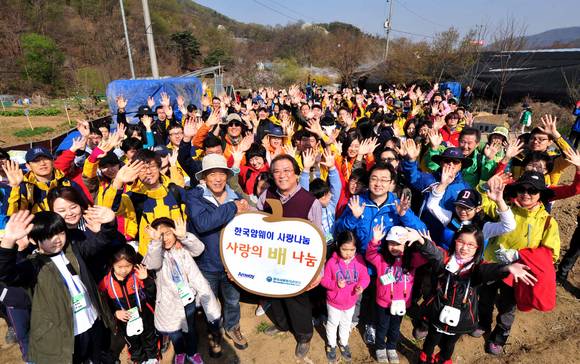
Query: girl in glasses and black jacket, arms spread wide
407 225 537 364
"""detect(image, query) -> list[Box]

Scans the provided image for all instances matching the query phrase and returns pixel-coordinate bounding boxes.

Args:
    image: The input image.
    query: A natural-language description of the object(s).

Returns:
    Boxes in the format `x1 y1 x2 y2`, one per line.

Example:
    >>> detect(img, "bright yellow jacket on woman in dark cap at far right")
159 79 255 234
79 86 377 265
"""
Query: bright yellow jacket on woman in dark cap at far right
482 194 560 262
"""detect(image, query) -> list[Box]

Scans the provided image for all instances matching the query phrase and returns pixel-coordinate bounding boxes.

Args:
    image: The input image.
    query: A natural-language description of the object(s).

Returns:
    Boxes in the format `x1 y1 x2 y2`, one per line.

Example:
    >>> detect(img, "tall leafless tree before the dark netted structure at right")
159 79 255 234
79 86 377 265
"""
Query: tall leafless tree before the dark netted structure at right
491 17 527 113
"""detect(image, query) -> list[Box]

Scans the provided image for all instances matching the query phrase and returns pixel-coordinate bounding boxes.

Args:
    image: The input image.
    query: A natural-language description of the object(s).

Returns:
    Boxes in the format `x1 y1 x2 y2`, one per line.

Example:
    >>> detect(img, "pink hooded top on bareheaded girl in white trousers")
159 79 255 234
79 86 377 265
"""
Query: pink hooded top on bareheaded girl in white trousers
320 252 371 310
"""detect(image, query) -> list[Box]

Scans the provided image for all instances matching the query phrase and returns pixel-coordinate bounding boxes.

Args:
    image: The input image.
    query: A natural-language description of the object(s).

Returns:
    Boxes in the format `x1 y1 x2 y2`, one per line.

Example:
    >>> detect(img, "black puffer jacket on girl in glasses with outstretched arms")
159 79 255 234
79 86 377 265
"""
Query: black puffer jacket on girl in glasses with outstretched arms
421 241 509 334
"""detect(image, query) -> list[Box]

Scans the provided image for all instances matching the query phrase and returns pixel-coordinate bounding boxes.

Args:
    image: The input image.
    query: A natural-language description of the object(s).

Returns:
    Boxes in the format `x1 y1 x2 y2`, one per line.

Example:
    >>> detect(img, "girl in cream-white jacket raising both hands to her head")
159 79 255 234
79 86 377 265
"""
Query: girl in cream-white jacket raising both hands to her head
143 217 221 364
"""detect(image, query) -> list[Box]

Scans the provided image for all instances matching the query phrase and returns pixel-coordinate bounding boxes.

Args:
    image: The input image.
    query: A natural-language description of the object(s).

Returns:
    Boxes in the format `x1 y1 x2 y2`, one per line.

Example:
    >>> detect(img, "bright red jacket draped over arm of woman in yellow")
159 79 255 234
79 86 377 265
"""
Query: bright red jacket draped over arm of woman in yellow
504 247 556 312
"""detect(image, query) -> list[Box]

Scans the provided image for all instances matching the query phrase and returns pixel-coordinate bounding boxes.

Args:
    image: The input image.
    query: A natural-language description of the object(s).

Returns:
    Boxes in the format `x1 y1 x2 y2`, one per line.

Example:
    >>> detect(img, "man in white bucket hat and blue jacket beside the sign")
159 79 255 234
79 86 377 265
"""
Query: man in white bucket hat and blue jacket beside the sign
186 154 249 357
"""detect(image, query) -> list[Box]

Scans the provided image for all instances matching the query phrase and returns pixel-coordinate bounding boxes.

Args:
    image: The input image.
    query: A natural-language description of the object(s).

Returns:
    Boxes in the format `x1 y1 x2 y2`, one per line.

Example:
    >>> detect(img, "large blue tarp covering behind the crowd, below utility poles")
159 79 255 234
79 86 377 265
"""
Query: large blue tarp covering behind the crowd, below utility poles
107 77 202 123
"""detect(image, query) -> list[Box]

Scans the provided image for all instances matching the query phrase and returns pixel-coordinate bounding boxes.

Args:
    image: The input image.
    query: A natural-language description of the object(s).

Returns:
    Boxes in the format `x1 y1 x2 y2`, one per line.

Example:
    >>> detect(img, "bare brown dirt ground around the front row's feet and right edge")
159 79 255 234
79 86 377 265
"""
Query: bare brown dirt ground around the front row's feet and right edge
0 146 580 364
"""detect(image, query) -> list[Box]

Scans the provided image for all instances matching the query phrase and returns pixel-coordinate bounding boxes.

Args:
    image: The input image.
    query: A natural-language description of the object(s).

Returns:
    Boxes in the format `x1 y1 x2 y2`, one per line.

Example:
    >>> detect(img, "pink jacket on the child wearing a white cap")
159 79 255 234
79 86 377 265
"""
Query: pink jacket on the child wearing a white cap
366 241 425 308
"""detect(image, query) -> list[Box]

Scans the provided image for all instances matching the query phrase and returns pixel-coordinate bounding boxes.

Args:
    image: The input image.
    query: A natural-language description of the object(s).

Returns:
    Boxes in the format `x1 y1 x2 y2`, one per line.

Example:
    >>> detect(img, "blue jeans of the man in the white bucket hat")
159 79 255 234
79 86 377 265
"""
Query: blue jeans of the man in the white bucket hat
201 271 240 331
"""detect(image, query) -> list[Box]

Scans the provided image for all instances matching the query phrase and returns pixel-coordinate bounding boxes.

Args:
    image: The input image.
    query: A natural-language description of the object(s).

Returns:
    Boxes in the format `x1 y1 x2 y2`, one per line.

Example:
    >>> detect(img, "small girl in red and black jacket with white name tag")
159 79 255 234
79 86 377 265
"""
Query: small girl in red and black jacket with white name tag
99 244 159 364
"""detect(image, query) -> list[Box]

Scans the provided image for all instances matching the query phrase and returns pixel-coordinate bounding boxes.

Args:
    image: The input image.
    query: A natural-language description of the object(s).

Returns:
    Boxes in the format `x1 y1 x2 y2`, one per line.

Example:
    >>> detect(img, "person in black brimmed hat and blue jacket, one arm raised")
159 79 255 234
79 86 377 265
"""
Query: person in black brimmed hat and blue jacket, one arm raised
401 140 472 249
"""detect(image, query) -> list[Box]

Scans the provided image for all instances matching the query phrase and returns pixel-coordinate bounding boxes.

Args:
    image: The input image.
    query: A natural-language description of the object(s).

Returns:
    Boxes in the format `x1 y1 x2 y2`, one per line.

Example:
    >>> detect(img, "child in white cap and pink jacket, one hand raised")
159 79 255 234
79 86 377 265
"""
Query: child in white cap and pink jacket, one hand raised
366 221 424 364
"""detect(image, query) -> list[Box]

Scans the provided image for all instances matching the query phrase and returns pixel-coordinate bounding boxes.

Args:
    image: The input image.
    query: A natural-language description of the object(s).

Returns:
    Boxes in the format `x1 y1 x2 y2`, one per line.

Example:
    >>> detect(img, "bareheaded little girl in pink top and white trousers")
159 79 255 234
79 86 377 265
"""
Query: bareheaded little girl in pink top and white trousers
320 231 370 362
